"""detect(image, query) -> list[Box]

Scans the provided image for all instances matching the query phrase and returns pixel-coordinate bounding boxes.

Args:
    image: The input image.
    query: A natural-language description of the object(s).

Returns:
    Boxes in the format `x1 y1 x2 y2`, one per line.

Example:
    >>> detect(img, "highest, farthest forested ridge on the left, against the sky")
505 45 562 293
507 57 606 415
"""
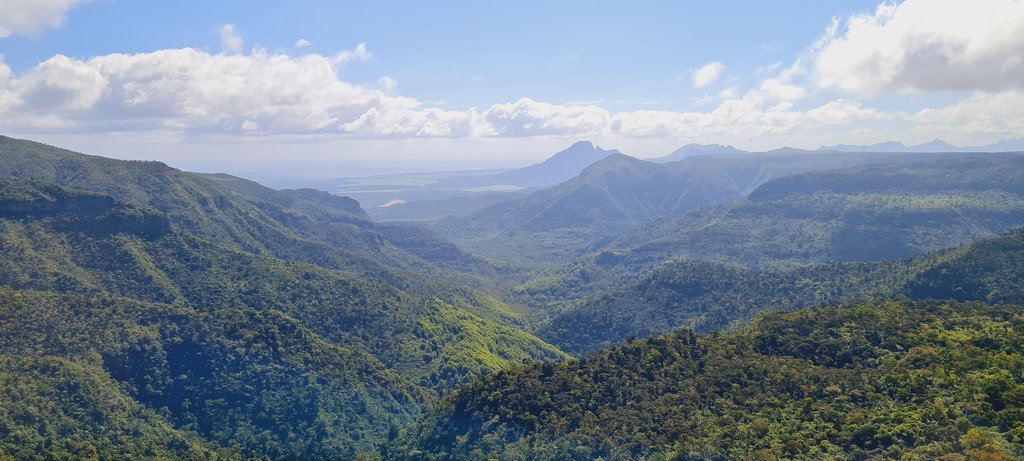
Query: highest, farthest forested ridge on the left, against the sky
0 136 491 289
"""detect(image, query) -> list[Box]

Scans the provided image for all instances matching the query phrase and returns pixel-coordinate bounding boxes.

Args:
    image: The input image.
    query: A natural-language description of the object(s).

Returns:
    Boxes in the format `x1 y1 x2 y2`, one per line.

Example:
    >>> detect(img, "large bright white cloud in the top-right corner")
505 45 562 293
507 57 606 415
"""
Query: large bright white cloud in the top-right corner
813 0 1024 96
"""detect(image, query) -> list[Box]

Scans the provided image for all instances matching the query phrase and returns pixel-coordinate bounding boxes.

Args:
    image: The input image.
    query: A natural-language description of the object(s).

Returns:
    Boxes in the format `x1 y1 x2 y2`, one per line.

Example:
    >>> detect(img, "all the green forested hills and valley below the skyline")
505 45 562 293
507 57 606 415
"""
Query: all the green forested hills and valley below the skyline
0 136 1024 460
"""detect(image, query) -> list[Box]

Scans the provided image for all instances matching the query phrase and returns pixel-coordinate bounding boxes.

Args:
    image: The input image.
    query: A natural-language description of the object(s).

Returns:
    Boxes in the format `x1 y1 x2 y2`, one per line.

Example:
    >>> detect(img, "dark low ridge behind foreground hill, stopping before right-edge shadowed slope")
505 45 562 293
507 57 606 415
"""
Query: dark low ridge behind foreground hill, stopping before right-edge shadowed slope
538 259 907 354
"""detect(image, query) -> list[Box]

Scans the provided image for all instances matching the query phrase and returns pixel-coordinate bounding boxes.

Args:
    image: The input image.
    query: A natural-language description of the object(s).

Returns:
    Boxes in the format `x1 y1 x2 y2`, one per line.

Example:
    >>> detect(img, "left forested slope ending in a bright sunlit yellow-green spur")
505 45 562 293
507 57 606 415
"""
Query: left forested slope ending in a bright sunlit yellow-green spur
0 176 561 389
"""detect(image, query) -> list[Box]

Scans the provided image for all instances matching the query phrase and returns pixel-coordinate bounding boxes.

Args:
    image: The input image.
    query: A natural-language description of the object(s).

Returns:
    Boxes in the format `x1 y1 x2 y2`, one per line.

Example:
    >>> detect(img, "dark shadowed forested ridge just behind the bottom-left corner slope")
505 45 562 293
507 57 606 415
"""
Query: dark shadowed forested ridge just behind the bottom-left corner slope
0 289 425 459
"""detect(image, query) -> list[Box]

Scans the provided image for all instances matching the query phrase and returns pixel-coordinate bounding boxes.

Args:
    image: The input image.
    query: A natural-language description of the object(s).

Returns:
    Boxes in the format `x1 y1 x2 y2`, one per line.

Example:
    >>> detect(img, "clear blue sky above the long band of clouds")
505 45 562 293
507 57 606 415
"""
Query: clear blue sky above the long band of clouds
4 0 877 111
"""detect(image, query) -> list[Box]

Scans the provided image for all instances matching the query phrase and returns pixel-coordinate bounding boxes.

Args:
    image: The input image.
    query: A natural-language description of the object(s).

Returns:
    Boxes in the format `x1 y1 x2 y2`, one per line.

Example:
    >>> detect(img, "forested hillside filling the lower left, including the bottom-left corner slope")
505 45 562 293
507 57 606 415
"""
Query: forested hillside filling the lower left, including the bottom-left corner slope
0 289 427 459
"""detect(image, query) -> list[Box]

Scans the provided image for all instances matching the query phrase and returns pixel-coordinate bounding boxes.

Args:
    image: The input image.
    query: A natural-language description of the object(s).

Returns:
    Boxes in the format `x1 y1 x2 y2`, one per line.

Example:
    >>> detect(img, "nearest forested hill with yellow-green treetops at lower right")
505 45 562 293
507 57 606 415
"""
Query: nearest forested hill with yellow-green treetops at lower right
389 301 1024 460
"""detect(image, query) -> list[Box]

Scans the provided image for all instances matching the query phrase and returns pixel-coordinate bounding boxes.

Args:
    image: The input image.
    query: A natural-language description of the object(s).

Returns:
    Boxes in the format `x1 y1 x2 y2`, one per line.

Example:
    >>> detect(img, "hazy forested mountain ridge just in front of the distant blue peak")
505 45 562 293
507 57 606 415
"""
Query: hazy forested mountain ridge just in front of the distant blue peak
431 151 1007 265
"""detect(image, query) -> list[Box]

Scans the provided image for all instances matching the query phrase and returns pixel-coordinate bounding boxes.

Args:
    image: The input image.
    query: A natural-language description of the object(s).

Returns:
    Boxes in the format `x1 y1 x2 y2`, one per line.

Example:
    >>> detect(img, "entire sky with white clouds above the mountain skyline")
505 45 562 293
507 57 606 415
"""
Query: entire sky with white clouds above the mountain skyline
0 0 1024 178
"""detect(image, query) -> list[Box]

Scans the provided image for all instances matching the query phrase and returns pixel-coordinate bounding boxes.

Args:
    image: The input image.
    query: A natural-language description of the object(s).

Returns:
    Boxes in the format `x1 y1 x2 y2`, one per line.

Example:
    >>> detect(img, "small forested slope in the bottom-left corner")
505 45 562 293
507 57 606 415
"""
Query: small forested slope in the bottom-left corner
0 353 242 460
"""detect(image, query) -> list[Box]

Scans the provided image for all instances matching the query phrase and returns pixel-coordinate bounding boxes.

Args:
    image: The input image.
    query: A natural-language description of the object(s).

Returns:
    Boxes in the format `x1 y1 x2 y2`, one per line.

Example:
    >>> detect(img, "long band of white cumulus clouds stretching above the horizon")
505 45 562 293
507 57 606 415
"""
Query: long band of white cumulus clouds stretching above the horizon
0 44 1007 145
